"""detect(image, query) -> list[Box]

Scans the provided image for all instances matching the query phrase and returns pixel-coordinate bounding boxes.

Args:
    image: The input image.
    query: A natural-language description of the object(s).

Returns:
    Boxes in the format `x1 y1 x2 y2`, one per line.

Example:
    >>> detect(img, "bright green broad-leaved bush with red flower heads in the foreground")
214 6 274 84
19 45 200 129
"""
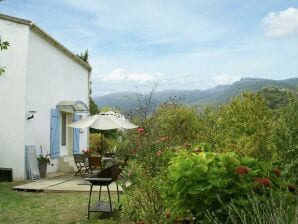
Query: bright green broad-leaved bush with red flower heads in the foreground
162 150 285 220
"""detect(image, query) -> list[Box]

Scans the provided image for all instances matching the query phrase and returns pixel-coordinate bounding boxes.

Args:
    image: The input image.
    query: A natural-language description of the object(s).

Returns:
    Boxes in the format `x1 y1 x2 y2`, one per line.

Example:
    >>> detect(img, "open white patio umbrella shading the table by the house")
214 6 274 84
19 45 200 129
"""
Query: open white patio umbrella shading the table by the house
67 111 138 130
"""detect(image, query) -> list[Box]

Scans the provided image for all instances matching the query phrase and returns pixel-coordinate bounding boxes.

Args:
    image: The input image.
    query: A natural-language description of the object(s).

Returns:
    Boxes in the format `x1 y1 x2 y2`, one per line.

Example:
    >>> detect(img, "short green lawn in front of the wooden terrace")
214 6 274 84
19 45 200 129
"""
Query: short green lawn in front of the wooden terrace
0 183 122 224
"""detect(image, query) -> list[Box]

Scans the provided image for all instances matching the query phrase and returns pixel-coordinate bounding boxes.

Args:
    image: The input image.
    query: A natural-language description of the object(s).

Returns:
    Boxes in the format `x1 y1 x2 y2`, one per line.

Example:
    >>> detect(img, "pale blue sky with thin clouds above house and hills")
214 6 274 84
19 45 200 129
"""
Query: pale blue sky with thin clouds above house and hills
0 0 298 96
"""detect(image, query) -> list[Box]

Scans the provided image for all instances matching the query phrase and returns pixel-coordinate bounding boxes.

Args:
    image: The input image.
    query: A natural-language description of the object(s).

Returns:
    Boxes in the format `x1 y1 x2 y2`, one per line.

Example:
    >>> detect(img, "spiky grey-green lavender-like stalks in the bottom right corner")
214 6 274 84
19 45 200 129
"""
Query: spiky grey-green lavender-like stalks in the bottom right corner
206 191 298 224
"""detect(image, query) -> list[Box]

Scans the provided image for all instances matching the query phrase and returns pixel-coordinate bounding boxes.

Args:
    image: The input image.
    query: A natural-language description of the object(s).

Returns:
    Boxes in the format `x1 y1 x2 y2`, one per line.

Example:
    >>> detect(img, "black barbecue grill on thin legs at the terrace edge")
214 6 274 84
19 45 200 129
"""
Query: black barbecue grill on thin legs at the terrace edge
85 165 121 219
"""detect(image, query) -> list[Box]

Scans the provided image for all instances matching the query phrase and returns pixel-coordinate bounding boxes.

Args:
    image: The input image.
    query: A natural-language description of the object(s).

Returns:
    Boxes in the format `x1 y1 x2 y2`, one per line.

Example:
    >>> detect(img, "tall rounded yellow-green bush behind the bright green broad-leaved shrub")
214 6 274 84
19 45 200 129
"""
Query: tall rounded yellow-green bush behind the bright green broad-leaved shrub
198 93 275 160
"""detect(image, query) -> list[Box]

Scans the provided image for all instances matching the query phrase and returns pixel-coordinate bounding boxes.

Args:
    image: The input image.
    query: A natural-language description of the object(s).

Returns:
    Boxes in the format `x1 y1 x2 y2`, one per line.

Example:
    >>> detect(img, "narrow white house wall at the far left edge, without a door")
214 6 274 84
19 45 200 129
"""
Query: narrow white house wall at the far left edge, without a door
0 19 29 179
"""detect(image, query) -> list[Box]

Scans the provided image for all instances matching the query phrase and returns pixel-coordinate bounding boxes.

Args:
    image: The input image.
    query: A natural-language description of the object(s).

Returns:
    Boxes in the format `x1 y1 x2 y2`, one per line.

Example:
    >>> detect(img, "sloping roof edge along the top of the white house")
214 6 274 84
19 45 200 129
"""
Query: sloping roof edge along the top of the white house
0 13 92 72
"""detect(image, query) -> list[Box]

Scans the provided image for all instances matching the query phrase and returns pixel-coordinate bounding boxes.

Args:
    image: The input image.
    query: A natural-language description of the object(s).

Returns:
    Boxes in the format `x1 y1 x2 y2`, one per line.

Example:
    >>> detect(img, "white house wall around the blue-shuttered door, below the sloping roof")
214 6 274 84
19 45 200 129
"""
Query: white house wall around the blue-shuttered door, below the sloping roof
25 30 89 175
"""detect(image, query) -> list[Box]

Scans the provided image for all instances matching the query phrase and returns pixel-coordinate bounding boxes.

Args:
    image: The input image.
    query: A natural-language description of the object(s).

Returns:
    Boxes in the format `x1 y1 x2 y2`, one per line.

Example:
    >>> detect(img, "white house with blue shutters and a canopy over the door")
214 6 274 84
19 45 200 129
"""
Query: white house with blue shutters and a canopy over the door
0 14 91 180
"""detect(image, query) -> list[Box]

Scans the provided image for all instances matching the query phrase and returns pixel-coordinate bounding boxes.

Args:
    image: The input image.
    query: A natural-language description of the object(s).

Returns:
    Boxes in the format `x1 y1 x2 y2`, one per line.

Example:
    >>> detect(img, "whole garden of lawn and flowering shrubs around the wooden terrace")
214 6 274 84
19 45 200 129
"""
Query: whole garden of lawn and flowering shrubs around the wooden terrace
0 89 298 224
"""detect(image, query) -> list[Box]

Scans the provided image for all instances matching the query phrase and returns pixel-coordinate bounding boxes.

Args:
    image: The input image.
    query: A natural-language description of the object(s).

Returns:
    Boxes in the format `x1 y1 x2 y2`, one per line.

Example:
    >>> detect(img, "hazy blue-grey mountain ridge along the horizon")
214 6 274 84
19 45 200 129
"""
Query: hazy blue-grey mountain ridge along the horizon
93 78 298 112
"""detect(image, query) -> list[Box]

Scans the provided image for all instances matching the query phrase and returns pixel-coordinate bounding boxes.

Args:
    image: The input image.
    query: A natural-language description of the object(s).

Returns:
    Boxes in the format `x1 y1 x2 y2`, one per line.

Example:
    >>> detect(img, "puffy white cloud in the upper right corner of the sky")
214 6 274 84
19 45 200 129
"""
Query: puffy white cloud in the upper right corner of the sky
262 7 298 37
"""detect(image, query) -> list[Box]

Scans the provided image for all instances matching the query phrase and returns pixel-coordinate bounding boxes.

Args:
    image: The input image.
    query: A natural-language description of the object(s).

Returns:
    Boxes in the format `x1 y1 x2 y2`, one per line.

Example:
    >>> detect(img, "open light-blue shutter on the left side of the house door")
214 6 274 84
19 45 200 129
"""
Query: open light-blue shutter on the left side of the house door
50 109 60 159
